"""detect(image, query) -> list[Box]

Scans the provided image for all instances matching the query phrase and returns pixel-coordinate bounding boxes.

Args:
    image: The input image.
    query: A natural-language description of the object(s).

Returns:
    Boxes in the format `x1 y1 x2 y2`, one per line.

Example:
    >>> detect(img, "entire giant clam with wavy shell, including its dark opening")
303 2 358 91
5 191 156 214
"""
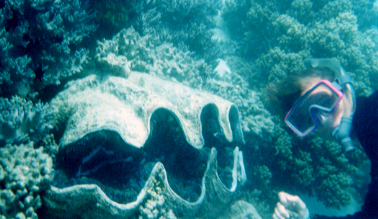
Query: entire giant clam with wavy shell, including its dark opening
45 72 259 218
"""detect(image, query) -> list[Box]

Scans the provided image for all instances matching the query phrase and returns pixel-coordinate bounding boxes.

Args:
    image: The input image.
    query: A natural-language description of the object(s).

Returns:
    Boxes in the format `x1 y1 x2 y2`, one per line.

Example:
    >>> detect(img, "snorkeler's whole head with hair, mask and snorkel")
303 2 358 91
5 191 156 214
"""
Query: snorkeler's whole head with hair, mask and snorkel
267 59 355 151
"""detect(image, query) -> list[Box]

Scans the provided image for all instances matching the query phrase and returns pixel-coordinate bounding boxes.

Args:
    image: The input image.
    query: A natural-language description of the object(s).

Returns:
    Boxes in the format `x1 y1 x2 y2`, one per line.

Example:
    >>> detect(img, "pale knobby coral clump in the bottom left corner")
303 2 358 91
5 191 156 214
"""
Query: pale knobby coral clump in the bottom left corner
0 142 53 218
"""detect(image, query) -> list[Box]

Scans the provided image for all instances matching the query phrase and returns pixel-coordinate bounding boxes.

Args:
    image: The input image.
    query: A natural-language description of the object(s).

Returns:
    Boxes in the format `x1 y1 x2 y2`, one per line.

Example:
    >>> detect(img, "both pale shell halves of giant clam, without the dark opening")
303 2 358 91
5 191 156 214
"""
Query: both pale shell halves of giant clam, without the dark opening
44 72 259 218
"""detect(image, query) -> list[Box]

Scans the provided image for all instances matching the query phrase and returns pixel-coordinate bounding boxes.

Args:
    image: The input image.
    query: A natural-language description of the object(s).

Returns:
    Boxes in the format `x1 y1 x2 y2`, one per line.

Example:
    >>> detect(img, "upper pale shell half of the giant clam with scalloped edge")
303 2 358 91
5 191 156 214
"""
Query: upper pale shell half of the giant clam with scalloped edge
50 72 243 149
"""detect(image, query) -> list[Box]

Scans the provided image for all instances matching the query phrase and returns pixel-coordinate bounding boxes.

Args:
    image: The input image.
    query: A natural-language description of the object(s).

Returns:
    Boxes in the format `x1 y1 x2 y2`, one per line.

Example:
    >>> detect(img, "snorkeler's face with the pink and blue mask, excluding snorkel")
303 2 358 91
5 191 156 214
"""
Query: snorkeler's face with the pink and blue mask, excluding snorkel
292 76 345 139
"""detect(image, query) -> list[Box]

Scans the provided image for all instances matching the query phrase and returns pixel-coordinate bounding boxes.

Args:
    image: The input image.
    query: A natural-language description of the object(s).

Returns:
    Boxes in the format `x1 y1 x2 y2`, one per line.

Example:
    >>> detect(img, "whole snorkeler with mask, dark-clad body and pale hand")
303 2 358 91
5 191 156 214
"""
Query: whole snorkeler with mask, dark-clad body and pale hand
267 59 378 219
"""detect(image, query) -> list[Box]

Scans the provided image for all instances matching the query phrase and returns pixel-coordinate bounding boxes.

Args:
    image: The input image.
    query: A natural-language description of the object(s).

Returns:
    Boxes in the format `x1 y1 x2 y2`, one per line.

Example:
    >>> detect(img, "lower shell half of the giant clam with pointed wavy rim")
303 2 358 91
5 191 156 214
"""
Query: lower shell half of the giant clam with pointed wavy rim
44 147 255 219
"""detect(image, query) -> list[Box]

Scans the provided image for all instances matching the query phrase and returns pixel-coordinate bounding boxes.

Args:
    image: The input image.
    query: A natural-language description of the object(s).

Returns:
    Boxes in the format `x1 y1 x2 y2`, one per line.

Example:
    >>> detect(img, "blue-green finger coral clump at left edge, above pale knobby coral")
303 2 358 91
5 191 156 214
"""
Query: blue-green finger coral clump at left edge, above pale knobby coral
0 96 55 144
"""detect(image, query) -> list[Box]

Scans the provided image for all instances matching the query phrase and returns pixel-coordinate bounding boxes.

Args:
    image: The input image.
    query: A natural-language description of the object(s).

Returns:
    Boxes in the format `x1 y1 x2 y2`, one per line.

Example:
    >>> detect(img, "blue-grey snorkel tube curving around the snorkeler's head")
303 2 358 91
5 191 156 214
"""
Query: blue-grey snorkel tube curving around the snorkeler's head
304 58 356 152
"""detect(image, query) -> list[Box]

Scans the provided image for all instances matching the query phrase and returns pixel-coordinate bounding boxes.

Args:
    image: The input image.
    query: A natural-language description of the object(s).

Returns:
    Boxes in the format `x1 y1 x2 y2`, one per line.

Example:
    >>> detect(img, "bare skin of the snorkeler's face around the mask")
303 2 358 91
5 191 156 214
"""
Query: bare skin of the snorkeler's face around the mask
301 77 345 137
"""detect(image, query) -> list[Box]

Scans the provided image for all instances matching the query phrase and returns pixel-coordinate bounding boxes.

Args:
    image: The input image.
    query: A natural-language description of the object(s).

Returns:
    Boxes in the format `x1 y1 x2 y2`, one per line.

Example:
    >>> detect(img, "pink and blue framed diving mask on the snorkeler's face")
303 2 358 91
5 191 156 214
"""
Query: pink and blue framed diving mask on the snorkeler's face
285 80 343 137
